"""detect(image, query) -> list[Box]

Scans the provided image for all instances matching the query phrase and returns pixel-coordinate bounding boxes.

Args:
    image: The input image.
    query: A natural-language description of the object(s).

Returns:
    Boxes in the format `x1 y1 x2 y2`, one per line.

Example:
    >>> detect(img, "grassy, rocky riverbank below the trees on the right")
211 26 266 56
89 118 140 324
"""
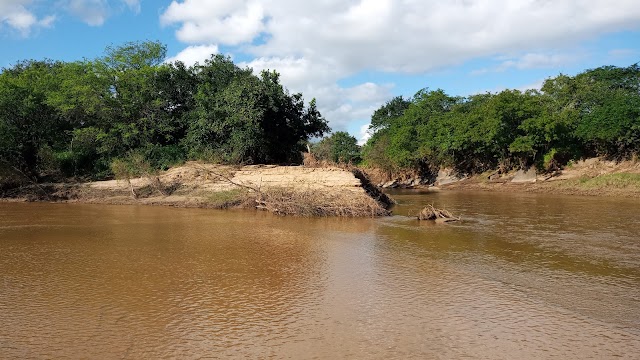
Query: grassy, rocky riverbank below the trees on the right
376 158 640 198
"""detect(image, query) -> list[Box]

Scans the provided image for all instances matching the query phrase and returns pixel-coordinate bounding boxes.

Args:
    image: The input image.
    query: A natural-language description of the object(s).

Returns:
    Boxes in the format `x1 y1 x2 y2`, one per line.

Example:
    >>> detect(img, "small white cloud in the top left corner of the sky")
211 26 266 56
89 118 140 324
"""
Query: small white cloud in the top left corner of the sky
0 0 55 36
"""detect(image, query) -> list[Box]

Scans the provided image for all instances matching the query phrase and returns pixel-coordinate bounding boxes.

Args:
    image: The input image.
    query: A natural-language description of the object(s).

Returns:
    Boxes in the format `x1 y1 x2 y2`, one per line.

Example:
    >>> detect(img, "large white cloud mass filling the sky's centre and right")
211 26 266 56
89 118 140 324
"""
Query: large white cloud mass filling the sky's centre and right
161 0 640 134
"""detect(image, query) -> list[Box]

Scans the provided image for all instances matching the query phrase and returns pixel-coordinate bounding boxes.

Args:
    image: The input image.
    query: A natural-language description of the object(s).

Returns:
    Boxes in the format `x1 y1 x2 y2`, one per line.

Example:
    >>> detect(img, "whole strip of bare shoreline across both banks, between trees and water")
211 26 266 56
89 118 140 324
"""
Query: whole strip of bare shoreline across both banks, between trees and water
0 159 640 212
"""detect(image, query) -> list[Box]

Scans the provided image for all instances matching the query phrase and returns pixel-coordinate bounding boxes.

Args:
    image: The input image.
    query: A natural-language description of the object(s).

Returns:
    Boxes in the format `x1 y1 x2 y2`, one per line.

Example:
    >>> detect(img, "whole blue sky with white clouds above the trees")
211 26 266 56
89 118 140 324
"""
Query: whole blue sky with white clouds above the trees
0 0 640 142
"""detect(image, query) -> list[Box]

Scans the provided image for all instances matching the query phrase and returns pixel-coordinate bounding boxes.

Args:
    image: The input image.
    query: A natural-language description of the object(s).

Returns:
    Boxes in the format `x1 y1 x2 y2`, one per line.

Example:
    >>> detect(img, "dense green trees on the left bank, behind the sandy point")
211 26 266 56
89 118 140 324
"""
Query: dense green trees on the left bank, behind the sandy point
0 42 329 180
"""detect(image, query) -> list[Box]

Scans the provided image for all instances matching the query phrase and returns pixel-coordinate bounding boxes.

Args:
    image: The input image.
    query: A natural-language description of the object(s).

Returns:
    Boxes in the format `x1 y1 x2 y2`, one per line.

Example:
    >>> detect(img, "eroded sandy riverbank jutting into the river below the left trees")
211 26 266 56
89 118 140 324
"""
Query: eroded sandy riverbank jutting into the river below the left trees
0 162 393 217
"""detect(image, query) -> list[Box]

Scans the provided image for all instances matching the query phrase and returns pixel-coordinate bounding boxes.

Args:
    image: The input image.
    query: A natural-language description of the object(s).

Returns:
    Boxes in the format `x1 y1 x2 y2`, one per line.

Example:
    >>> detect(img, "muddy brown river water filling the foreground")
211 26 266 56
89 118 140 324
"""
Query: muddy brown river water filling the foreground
0 192 640 359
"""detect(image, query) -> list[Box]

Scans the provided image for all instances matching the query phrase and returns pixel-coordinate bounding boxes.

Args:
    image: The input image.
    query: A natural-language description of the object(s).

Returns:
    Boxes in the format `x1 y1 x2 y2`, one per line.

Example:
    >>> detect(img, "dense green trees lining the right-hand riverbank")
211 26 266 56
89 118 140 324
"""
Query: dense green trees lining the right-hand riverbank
363 64 640 177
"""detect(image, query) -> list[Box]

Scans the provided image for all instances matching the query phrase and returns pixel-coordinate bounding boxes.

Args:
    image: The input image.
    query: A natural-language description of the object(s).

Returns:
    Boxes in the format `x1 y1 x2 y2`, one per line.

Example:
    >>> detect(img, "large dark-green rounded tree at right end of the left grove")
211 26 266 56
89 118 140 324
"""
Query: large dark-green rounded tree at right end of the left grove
185 57 328 163
